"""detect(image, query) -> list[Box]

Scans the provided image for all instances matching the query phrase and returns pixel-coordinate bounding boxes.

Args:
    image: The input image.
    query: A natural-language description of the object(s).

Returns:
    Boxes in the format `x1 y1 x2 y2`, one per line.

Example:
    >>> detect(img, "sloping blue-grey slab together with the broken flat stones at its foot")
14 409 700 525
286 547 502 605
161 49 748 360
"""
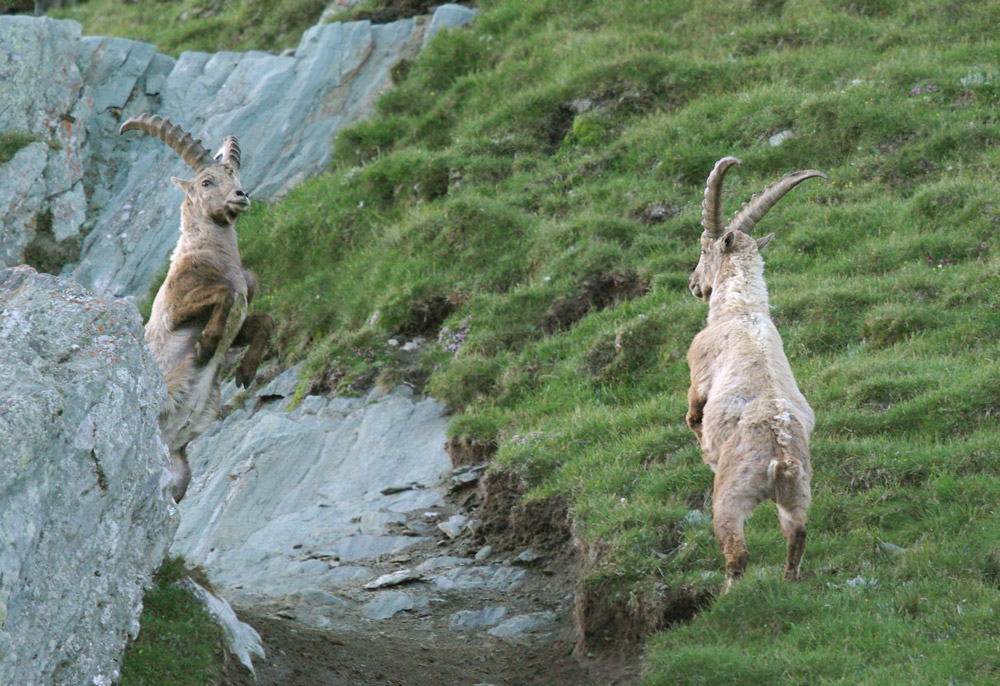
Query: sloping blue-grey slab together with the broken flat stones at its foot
165 368 572 645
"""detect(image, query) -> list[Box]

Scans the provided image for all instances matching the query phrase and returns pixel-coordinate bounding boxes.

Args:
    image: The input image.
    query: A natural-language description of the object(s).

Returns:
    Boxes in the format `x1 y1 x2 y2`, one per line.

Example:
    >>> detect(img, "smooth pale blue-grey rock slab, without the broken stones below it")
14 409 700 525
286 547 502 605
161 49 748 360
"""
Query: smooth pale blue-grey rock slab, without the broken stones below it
172 376 451 602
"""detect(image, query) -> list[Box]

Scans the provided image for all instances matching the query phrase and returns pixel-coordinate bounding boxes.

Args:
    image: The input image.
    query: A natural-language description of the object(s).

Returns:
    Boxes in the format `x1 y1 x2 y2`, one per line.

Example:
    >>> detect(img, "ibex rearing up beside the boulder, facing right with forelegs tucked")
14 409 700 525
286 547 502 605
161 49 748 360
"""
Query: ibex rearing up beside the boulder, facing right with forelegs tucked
119 114 274 502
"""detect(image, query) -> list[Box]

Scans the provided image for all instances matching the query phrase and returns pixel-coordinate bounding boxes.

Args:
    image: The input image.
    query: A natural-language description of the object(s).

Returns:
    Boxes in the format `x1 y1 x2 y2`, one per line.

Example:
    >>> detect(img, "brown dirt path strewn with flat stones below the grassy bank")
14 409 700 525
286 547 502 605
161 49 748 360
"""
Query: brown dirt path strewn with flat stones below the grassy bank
221 520 639 686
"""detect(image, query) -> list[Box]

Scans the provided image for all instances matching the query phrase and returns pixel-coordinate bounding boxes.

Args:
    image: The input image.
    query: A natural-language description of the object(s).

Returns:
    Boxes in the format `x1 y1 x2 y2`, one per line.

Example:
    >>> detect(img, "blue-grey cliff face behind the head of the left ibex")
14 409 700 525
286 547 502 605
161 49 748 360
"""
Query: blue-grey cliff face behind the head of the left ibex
0 5 475 296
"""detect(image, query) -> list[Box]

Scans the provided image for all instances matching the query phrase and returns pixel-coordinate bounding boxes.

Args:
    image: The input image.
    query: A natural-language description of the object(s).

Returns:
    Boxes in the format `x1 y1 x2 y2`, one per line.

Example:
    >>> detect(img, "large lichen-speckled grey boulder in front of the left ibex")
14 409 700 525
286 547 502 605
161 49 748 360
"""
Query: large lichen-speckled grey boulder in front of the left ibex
0 267 177 686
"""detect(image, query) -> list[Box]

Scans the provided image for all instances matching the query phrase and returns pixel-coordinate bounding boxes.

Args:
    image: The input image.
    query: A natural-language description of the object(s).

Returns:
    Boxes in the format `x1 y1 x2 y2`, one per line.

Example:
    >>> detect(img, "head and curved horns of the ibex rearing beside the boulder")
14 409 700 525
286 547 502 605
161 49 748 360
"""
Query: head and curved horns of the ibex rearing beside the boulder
118 114 250 226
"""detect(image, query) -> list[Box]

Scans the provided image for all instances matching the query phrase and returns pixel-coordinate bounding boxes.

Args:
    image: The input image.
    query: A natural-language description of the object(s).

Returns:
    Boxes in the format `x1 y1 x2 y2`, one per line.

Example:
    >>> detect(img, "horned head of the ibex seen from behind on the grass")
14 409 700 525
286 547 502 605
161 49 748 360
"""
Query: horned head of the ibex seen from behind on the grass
688 157 826 302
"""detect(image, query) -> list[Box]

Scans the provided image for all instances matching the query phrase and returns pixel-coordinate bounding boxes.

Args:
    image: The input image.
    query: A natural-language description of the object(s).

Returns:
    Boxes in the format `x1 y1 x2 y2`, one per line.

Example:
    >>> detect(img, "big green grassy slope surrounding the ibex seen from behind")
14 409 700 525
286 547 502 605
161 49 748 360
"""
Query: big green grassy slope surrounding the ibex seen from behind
64 0 1000 684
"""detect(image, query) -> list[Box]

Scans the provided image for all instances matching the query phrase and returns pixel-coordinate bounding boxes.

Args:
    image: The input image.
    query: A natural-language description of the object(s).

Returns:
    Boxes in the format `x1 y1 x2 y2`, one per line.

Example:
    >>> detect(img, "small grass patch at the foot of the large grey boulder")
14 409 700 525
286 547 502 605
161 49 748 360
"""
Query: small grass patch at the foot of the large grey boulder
119 557 224 686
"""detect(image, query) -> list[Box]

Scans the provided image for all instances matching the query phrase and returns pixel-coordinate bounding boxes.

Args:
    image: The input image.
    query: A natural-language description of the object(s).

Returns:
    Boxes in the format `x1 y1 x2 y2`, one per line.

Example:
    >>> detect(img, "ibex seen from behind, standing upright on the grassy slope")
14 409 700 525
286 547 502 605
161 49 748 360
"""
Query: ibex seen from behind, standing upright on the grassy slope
687 157 826 590
